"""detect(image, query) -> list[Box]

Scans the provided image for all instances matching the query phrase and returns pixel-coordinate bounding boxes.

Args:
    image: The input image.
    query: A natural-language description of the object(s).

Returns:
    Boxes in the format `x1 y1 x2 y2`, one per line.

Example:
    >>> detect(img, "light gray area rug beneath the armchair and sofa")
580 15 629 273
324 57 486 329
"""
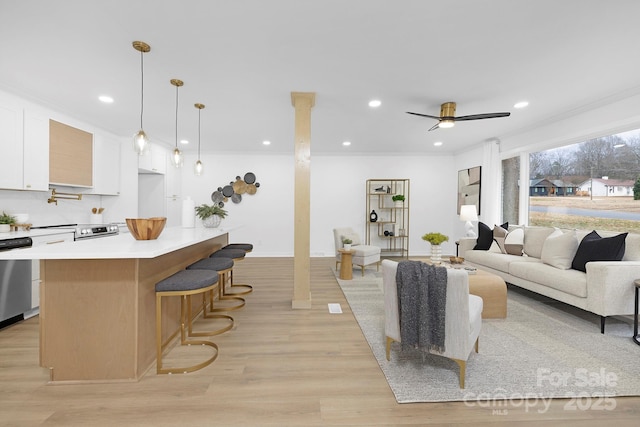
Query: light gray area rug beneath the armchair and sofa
334 270 640 410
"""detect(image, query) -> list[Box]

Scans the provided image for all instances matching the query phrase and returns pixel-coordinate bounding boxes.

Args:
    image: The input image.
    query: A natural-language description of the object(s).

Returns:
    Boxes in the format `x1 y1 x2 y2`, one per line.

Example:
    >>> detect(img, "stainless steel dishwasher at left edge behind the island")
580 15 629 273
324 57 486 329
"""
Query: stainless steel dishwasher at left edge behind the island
0 237 32 327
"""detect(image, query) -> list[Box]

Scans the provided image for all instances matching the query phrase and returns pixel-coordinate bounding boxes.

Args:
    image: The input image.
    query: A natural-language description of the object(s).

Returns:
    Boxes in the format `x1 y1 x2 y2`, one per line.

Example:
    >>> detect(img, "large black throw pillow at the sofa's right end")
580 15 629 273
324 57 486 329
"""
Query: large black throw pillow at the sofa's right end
571 230 629 273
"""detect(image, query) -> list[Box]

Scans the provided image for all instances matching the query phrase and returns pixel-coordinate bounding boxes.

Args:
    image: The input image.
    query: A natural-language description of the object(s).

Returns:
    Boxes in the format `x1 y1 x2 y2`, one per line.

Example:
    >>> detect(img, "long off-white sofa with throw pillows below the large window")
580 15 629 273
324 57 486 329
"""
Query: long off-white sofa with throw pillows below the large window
459 227 640 333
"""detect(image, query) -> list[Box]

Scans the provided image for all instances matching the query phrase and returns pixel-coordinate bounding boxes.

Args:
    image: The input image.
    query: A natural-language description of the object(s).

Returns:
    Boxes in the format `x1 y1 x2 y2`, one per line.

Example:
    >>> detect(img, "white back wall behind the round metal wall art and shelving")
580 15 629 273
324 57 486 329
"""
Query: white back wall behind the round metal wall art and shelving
182 153 463 257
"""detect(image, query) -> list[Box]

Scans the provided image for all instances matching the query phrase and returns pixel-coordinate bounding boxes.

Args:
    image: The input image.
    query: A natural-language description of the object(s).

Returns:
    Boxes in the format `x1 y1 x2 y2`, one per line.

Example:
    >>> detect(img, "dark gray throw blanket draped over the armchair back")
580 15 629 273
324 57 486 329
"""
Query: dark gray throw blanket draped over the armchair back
396 261 447 353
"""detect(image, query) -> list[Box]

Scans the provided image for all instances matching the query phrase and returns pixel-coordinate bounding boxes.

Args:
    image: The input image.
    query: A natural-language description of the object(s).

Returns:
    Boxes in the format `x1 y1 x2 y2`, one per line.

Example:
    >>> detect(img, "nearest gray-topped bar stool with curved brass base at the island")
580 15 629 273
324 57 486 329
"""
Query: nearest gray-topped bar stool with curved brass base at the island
156 270 219 374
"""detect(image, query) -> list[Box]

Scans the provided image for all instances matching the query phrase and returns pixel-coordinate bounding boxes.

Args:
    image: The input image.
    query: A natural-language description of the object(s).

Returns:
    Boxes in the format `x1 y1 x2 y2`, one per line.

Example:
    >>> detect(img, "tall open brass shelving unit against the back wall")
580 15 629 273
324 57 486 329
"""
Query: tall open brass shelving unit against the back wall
366 179 410 258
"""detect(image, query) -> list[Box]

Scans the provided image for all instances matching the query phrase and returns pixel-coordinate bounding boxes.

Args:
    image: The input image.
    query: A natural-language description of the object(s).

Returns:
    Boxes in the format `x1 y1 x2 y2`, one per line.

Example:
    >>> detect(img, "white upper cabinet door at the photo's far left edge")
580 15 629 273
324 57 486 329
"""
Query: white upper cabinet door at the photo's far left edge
0 104 24 190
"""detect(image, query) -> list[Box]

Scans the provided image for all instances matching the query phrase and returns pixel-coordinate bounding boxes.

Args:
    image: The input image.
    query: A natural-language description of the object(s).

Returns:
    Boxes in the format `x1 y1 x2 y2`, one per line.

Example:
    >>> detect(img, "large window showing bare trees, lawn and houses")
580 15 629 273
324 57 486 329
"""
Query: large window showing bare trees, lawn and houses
524 131 640 232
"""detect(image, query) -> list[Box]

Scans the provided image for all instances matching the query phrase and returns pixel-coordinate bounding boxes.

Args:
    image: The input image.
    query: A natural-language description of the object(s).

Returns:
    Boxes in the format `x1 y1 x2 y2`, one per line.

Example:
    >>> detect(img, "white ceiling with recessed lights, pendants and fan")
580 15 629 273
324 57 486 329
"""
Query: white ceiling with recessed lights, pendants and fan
0 0 640 154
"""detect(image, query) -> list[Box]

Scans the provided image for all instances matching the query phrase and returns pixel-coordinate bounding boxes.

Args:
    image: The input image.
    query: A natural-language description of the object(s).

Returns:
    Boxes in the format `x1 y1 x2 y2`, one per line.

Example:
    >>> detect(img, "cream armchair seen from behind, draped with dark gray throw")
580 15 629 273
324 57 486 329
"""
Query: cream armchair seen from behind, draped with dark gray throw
382 260 483 388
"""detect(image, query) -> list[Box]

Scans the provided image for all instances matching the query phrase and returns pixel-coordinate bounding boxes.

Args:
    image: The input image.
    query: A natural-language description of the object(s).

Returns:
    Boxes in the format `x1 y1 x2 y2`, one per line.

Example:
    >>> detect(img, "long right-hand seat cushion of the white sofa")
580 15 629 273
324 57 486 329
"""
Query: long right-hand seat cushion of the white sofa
509 258 587 298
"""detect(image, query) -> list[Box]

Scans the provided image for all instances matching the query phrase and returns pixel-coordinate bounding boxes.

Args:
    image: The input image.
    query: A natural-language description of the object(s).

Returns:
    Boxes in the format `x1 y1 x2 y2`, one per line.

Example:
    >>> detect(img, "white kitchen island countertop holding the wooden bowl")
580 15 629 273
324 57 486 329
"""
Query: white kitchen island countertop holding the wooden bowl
0 227 232 260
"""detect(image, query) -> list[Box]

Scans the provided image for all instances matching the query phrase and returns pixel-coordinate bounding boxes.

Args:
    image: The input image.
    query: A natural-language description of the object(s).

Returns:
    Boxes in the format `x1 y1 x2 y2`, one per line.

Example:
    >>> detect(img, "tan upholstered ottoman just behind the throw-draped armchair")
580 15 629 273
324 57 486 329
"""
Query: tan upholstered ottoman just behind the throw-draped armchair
469 270 507 319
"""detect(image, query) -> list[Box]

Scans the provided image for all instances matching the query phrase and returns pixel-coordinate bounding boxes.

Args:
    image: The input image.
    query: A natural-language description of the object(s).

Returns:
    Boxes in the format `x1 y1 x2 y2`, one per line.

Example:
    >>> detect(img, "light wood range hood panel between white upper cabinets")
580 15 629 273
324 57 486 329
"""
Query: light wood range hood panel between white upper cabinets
49 120 93 187
